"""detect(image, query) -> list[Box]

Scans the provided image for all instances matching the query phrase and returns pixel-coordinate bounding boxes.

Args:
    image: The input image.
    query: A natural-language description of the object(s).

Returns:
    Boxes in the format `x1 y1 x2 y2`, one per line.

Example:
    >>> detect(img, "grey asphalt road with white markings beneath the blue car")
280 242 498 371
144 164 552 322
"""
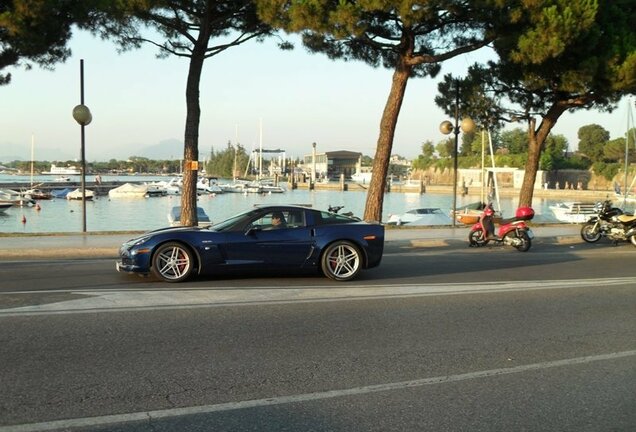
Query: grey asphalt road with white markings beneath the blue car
0 243 636 432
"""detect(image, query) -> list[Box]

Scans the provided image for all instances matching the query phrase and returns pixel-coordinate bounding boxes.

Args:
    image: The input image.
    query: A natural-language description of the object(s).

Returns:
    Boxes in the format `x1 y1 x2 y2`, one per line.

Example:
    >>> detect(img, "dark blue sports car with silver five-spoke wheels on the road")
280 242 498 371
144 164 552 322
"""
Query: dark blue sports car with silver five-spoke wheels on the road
117 205 384 282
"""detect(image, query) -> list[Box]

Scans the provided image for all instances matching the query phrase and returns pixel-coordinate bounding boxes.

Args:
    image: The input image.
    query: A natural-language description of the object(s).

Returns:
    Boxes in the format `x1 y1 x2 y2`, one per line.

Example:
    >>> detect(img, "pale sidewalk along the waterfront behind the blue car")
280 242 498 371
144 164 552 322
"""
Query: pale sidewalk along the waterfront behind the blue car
0 224 582 261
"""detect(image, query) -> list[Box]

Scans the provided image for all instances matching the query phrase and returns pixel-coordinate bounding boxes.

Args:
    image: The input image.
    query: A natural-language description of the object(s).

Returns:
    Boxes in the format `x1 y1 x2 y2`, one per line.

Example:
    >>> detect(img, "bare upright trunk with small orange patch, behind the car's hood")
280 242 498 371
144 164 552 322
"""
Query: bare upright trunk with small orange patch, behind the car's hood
181 48 205 226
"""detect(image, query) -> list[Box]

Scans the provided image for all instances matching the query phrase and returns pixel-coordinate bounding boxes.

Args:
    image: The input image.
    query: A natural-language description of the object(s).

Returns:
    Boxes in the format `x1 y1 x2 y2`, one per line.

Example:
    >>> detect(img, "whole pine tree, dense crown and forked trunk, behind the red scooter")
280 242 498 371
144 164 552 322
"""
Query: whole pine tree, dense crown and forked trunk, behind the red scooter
446 0 636 205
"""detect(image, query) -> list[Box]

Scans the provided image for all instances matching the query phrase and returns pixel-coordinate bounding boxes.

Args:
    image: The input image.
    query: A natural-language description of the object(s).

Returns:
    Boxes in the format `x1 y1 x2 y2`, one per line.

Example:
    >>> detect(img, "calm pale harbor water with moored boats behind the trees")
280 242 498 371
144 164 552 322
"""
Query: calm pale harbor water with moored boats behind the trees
0 175 608 233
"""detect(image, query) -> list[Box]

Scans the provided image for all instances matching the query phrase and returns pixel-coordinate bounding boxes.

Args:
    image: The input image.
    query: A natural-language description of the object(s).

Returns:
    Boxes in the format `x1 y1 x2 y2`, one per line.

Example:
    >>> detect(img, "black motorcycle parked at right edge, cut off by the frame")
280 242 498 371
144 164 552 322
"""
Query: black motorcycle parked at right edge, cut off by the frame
581 200 636 246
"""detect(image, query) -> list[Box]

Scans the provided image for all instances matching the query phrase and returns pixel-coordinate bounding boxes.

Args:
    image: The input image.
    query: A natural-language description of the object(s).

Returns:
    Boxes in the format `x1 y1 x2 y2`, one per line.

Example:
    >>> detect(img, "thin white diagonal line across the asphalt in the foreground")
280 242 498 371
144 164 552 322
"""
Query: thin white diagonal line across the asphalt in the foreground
0 350 636 432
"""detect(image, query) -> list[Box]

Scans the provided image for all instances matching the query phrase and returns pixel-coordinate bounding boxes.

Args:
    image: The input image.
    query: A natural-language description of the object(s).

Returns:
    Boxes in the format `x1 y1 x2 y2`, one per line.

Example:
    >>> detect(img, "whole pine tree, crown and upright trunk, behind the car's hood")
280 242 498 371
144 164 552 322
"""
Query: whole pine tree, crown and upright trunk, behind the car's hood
95 0 271 226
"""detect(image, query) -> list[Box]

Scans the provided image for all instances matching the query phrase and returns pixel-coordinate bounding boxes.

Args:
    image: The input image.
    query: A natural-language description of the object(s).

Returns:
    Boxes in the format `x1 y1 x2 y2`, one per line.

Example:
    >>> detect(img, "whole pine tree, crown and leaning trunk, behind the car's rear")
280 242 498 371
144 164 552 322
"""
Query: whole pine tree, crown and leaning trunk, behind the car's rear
256 0 498 221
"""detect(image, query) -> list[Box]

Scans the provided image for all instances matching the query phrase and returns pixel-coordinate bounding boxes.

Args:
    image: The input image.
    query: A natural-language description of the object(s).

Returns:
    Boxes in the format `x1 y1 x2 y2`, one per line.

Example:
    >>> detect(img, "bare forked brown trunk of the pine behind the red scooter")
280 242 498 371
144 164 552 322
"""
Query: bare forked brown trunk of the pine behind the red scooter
519 102 569 207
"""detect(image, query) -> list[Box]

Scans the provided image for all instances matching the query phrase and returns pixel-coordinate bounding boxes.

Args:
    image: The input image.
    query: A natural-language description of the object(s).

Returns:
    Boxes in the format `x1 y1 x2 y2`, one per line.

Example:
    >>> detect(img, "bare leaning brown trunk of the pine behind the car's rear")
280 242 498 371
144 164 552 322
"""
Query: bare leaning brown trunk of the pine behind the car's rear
364 64 411 222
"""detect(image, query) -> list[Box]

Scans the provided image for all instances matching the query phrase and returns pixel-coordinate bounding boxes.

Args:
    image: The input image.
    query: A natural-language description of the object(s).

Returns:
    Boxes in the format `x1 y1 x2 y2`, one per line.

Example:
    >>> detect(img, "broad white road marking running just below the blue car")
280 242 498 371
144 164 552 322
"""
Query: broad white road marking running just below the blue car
0 277 636 318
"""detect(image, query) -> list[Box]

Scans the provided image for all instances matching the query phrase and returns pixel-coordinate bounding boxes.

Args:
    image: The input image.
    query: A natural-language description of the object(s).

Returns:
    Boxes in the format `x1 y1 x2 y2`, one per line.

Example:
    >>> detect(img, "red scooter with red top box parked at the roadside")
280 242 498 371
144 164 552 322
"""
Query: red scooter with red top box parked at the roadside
468 204 534 252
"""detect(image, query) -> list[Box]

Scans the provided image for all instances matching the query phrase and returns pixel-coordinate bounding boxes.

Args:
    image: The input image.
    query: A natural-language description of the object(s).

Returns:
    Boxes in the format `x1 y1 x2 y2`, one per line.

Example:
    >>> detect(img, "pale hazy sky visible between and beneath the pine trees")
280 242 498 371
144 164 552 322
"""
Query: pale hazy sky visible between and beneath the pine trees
0 31 628 162
